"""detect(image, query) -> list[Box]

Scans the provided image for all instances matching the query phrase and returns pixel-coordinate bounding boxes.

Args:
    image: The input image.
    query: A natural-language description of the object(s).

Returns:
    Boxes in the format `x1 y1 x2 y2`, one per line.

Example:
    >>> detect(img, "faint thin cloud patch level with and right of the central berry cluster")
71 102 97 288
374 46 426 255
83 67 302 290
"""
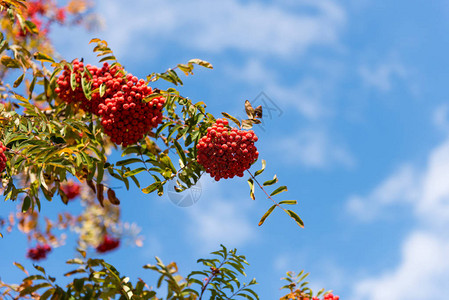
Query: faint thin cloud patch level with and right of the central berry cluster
276 129 355 168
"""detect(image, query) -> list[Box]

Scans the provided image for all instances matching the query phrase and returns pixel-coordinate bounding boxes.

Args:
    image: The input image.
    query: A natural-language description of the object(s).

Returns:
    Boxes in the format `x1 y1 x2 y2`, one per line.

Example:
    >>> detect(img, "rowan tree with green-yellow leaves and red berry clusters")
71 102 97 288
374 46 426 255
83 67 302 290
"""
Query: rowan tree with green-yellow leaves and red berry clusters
0 0 338 299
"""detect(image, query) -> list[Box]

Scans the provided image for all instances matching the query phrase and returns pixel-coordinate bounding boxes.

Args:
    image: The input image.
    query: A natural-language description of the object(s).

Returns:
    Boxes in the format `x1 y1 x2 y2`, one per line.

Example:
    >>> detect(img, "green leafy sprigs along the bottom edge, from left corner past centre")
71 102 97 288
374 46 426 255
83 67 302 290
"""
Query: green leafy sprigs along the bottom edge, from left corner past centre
0 246 259 300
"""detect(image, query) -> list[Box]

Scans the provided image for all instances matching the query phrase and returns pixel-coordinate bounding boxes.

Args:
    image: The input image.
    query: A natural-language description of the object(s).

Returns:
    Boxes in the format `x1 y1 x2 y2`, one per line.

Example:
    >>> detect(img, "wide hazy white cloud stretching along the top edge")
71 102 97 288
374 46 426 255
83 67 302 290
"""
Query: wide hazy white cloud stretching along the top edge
98 0 346 56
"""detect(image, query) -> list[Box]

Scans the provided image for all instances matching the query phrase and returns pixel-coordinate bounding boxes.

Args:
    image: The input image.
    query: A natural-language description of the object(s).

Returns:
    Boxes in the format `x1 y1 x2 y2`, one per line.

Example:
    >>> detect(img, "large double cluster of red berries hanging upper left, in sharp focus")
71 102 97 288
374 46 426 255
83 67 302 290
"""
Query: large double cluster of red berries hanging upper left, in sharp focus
55 60 165 147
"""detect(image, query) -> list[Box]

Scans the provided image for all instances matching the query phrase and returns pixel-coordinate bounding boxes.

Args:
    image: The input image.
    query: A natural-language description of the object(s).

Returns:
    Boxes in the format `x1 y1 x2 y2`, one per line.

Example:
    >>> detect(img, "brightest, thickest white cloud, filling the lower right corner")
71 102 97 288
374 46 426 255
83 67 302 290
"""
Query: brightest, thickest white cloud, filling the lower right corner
348 138 449 300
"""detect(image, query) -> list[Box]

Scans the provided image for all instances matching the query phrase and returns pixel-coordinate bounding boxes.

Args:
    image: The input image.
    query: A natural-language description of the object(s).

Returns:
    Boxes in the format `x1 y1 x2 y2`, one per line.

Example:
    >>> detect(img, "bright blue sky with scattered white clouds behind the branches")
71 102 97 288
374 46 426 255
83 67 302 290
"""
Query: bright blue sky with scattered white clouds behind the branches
0 0 449 300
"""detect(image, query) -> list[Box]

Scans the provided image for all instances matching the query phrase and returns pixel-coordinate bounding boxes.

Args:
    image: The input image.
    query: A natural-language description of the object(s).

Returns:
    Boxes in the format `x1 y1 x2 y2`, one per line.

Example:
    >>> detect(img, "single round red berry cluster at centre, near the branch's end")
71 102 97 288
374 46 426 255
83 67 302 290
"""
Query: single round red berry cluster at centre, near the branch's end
196 119 259 181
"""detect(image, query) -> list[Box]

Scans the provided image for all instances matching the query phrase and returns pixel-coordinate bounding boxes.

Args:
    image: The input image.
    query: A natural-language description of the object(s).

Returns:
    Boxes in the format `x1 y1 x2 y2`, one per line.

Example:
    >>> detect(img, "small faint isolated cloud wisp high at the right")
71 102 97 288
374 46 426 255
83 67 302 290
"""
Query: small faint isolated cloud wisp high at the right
359 62 407 92
